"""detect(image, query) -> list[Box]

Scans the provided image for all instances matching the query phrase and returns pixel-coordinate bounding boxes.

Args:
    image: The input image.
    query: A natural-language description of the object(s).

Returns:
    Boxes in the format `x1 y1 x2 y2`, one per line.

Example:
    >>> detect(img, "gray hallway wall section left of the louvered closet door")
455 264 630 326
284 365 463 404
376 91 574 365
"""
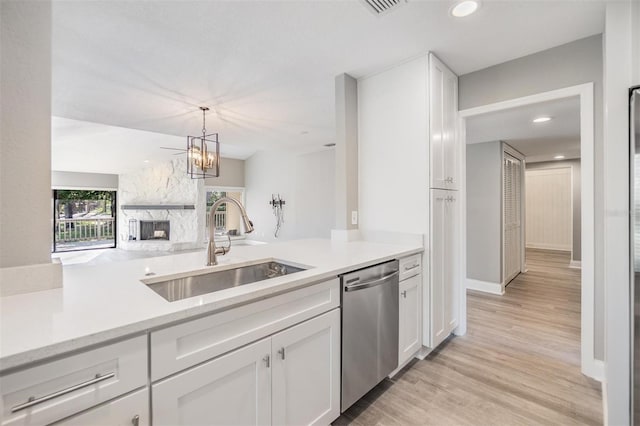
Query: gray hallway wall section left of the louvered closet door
467 141 502 284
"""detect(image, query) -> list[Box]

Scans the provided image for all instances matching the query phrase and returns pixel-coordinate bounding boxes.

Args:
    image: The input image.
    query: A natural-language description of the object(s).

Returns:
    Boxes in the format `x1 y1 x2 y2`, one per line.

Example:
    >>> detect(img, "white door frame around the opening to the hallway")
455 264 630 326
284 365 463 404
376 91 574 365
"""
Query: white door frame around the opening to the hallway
456 83 604 381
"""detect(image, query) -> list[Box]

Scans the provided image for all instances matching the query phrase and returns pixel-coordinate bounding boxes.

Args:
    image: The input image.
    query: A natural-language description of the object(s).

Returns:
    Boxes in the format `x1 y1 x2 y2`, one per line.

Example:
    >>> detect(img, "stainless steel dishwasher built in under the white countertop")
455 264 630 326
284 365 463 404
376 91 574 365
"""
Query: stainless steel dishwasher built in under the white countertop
341 260 399 411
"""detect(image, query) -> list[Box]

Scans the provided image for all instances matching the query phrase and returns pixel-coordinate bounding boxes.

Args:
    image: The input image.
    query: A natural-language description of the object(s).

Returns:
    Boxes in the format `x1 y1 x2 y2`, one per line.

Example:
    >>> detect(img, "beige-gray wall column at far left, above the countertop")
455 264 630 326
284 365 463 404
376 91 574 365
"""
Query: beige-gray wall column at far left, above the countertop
0 1 52 268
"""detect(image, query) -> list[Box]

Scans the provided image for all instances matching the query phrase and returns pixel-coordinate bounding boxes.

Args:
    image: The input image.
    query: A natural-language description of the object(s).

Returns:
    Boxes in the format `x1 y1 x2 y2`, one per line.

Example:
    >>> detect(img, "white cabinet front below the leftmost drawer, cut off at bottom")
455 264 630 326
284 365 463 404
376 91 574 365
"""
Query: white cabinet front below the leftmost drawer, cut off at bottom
54 389 151 426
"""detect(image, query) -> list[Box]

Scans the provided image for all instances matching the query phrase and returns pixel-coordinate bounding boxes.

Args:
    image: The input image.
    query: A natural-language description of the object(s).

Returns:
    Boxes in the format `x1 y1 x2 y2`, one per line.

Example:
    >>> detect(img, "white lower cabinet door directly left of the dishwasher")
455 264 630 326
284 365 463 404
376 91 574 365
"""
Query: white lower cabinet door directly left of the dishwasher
272 309 340 425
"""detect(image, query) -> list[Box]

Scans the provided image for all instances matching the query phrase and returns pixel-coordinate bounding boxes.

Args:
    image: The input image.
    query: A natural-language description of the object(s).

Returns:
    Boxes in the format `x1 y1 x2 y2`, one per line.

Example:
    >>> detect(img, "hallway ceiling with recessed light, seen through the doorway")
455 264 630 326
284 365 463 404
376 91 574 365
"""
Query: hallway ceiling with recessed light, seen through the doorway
466 96 580 162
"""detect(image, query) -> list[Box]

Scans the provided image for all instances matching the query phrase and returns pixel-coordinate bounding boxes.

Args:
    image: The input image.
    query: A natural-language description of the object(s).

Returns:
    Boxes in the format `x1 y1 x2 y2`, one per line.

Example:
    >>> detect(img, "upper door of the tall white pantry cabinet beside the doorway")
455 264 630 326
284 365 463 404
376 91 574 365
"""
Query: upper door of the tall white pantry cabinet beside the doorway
429 53 460 189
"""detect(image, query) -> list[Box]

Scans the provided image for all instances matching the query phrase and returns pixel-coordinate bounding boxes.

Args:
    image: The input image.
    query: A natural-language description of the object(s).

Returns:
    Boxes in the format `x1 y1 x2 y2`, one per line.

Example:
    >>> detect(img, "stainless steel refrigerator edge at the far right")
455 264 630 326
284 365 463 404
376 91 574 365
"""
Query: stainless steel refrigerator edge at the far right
629 87 640 424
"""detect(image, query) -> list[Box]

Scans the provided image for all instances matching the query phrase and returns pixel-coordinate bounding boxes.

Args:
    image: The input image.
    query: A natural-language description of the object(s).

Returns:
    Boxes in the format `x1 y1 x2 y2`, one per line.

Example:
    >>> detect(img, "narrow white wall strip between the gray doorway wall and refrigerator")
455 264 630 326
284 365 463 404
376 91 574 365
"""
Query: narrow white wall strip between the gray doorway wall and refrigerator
596 1 640 425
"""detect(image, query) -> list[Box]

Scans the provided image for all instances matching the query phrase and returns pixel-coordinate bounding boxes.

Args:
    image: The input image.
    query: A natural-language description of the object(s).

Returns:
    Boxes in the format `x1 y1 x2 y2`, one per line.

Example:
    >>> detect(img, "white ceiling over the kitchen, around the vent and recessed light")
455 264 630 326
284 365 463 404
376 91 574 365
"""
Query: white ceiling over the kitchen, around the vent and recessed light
52 0 604 172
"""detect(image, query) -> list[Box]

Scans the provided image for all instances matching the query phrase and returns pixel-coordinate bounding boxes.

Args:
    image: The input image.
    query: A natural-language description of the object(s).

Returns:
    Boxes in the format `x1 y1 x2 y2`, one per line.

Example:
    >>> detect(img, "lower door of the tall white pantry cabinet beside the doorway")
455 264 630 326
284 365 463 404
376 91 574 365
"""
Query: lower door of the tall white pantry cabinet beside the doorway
429 189 459 348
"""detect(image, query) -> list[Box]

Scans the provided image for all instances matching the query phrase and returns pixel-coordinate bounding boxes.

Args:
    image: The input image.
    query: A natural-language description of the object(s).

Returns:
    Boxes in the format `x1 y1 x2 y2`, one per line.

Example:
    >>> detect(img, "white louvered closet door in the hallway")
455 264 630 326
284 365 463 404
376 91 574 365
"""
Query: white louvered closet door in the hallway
502 153 522 284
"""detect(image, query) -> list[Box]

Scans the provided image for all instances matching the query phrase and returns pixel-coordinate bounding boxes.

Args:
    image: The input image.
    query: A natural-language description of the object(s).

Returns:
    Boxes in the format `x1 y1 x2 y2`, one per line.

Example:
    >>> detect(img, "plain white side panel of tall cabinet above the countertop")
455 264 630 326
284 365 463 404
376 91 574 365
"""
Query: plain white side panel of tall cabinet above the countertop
358 56 429 234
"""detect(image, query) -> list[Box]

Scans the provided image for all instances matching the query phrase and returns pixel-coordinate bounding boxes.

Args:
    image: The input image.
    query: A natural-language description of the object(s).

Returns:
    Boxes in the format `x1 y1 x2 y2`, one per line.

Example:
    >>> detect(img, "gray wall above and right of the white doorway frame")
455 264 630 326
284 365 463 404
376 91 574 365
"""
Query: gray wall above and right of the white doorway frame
458 34 604 360
